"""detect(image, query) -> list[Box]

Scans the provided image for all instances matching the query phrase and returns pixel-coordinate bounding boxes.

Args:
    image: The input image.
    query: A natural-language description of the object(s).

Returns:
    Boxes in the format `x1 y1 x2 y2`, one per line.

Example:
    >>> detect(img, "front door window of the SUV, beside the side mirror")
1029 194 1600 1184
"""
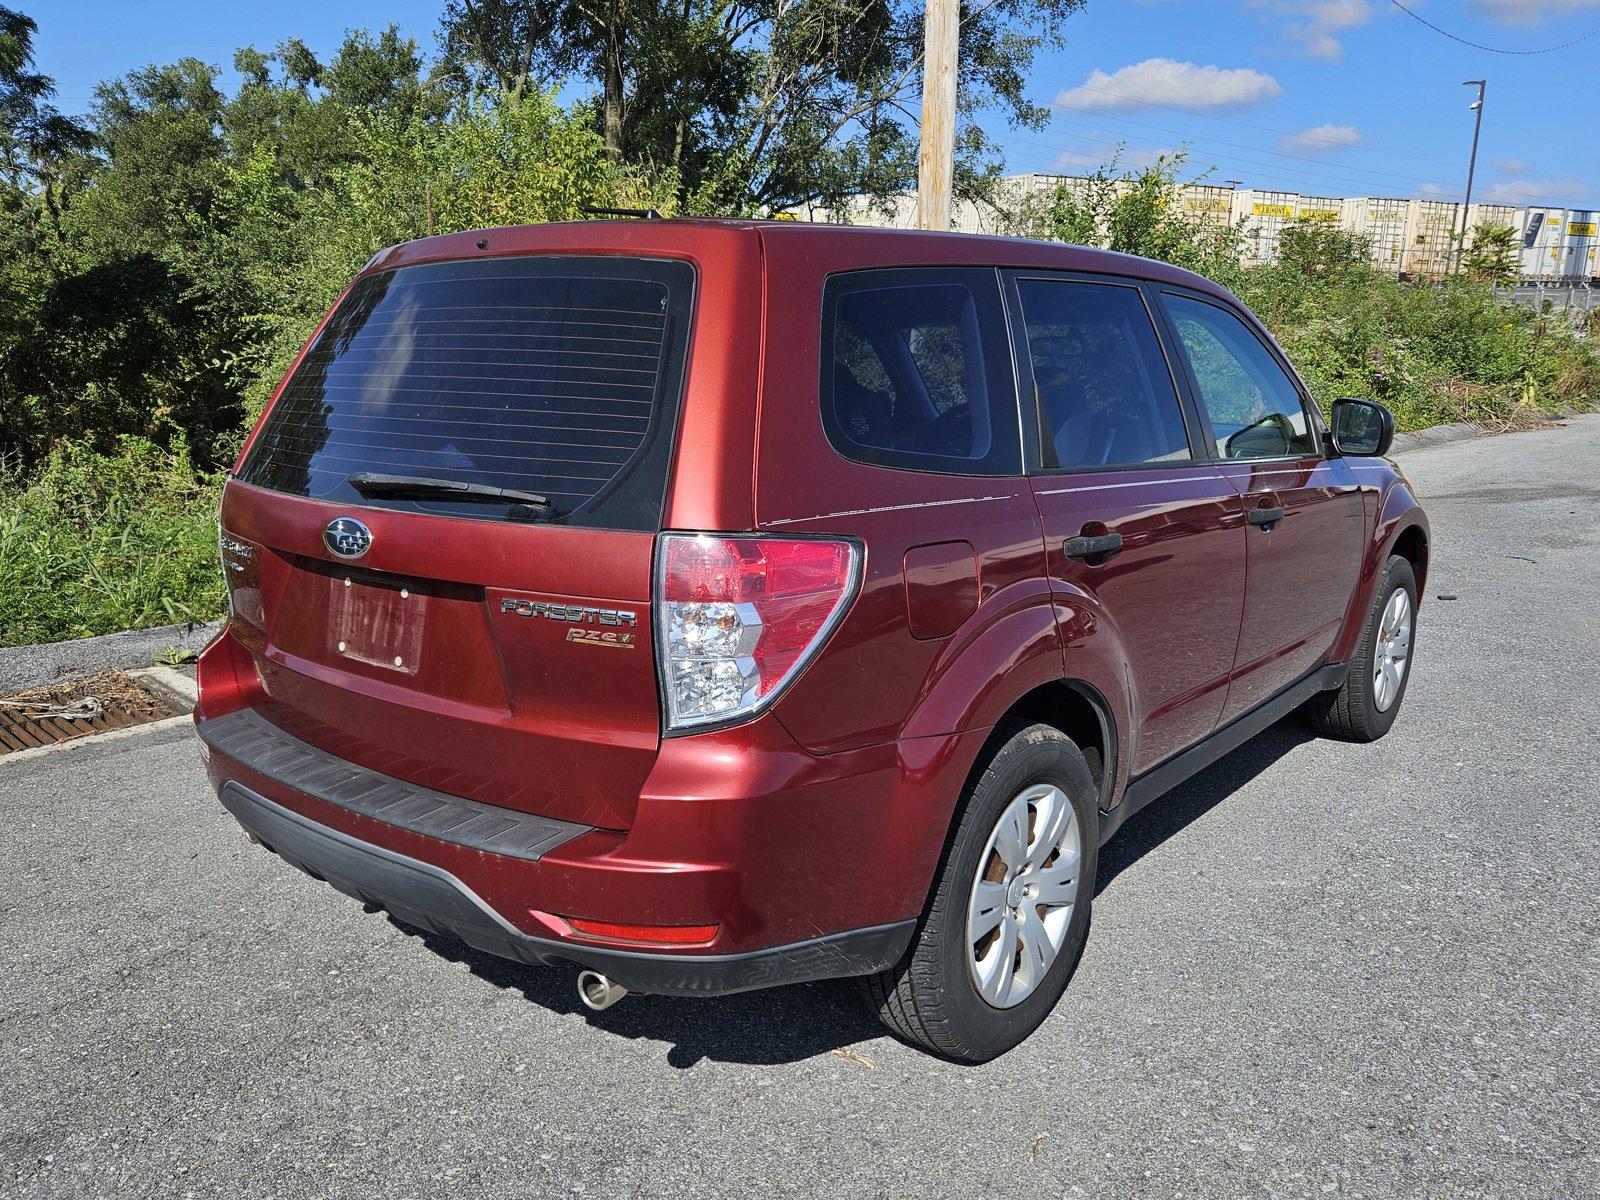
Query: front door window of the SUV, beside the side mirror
1163 294 1317 458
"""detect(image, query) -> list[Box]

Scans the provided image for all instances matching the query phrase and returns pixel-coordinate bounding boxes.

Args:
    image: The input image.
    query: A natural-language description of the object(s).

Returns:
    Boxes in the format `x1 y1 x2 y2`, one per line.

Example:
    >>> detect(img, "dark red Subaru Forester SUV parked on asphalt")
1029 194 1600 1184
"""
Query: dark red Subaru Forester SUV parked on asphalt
197 219 1429 1061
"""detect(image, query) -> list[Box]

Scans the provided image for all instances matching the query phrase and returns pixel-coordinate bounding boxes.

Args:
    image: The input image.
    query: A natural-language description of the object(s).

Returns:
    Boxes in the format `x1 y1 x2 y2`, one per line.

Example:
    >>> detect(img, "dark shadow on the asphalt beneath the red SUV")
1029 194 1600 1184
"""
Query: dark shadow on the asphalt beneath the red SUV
389 718 1312 1069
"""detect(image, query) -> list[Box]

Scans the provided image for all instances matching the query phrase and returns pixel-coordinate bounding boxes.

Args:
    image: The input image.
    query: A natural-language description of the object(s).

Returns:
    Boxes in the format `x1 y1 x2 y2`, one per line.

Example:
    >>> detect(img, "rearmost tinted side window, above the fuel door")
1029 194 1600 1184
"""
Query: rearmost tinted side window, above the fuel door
822 269 1021 474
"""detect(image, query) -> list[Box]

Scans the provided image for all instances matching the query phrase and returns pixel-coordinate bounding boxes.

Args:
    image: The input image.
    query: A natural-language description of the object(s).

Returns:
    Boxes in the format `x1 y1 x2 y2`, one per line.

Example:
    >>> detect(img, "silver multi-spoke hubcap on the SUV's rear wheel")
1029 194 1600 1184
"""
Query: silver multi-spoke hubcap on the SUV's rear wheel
966 784 1083 1008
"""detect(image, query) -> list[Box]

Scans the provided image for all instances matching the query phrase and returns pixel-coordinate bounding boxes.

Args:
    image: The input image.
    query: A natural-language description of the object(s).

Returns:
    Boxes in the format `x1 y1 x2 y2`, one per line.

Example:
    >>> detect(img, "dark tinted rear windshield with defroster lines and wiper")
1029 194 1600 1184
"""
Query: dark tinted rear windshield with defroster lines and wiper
238 256 694 530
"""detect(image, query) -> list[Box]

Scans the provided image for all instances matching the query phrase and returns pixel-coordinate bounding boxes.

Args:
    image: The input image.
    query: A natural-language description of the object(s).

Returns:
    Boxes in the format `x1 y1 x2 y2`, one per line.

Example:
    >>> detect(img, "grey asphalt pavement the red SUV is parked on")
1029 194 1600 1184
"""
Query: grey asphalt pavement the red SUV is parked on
0 418 1600 1200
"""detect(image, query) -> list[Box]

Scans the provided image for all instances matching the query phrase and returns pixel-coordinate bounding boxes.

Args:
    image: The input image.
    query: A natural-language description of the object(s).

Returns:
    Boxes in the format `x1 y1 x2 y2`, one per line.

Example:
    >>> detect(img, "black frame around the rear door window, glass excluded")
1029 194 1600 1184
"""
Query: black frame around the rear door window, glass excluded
1002 267 1211 475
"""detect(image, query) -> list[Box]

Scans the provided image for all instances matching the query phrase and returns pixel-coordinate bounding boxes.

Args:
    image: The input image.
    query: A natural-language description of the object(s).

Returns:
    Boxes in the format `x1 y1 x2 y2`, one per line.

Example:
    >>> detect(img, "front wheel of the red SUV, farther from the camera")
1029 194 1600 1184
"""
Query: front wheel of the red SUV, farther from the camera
1306 555 1416 742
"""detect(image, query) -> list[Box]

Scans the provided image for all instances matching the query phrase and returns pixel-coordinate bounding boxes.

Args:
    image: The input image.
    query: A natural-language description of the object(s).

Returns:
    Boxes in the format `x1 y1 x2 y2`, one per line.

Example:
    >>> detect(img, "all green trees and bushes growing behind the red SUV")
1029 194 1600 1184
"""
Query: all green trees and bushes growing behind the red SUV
0 9 1600 645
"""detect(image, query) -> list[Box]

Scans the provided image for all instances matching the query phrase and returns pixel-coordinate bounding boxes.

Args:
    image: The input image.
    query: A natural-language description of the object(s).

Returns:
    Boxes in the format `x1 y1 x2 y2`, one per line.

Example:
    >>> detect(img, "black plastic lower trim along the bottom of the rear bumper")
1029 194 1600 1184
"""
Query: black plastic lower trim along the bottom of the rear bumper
221 781 917 995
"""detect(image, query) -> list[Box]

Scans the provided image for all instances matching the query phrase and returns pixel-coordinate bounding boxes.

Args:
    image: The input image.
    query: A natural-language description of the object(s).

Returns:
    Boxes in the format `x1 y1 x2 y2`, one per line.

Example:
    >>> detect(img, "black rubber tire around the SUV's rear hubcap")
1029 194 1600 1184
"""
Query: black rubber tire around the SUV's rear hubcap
862 725 1099 1062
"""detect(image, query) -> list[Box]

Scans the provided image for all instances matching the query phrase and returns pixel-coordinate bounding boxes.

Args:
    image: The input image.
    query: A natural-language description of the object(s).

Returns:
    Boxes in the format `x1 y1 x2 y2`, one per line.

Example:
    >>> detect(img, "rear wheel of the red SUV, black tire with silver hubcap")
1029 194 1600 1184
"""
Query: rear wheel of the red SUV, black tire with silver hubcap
866 725 1099 1062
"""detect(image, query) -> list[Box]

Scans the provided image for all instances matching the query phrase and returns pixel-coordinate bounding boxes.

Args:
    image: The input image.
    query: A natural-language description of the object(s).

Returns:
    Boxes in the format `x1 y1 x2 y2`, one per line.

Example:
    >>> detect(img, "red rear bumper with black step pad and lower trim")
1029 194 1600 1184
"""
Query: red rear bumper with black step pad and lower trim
195 632 986 994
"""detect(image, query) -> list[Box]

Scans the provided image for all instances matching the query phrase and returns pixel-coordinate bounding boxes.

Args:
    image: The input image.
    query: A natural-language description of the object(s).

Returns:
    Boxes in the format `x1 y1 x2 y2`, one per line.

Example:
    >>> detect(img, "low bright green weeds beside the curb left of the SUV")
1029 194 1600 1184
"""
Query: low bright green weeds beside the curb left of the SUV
0 438 227 646
